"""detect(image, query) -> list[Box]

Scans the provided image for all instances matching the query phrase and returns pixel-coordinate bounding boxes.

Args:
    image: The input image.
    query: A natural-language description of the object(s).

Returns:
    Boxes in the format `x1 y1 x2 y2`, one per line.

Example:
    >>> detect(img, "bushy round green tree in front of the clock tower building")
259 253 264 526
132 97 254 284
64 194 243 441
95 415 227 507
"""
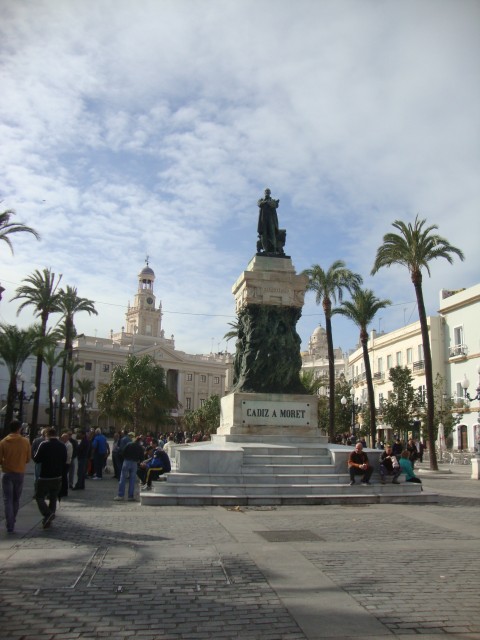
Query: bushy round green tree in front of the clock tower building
97 355 178 432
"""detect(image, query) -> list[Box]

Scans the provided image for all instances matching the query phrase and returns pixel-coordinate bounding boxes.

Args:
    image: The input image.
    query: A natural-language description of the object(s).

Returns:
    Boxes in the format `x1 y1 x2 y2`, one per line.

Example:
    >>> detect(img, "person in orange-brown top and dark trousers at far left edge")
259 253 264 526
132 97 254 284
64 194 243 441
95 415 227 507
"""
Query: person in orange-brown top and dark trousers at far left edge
0 420 31 533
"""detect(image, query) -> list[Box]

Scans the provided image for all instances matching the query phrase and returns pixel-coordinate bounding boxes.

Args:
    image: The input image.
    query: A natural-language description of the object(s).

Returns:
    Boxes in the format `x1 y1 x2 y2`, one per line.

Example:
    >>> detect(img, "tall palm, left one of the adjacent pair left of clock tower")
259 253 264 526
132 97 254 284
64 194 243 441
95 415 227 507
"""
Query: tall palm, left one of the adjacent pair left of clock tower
12 269 62 438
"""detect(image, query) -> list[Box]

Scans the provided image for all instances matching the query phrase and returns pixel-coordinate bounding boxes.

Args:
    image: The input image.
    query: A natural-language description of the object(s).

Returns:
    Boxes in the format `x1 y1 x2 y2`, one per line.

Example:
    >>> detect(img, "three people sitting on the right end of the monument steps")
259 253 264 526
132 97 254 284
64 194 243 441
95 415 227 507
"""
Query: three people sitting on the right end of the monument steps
348 442 422 486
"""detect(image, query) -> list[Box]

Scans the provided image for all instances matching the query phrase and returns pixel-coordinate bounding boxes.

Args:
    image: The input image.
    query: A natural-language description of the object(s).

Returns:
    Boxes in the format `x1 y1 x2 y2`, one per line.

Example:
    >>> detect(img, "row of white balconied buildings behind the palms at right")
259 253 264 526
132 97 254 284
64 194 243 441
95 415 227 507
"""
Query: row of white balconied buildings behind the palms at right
347 285 480 451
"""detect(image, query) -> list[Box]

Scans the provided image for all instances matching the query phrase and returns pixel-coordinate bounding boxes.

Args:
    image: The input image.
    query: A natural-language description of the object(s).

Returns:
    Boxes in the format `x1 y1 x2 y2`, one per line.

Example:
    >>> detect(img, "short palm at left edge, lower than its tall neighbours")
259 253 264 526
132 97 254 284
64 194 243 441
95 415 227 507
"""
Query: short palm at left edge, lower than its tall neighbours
0 324 39 432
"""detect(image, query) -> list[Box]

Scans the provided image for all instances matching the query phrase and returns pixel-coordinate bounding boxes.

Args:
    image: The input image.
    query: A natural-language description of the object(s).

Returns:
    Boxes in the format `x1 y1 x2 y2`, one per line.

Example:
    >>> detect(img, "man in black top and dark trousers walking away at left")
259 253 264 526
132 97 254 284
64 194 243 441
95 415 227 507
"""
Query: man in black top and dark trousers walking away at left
33 427 67 529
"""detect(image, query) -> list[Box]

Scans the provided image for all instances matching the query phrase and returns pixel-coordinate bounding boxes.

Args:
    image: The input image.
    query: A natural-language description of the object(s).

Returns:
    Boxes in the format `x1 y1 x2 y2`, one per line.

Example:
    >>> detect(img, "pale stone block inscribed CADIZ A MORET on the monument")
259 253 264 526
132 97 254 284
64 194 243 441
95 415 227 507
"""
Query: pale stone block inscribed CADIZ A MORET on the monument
217 391 320 437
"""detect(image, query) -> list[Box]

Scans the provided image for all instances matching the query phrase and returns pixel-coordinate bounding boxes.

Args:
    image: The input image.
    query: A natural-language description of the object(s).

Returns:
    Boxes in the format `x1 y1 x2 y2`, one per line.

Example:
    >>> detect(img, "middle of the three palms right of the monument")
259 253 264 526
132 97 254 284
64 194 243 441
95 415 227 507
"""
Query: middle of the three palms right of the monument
332 289 392 447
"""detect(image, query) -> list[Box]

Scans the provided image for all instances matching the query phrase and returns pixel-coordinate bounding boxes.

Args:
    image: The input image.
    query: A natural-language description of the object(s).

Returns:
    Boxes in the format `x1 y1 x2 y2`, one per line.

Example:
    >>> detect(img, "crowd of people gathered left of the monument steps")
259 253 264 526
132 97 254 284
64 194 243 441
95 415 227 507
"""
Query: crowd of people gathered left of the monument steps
0 420 175 533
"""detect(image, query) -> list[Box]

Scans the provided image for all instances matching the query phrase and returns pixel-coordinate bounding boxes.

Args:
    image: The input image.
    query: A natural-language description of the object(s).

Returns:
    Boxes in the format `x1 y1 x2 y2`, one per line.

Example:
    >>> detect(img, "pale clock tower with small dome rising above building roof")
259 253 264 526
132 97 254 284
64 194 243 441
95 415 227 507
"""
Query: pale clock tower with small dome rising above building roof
126 256 162 338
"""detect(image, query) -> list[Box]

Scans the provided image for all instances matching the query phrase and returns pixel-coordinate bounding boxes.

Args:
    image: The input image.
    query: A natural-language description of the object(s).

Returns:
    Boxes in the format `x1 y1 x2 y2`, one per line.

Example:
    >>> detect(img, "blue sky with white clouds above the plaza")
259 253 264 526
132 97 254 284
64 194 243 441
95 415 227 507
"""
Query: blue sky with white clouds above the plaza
0 0 480 353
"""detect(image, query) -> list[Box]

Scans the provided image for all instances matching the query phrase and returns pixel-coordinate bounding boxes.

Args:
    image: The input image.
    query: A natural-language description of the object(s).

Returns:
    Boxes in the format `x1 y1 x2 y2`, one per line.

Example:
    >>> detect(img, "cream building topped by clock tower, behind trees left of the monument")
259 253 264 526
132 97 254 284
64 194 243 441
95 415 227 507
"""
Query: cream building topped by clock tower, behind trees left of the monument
0 264 232 427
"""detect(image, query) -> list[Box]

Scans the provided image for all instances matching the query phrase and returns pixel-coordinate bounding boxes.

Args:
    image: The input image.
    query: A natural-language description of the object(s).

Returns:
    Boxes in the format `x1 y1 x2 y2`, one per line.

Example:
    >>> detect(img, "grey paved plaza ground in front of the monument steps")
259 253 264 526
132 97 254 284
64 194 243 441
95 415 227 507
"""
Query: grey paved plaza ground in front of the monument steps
0 466 480 640
